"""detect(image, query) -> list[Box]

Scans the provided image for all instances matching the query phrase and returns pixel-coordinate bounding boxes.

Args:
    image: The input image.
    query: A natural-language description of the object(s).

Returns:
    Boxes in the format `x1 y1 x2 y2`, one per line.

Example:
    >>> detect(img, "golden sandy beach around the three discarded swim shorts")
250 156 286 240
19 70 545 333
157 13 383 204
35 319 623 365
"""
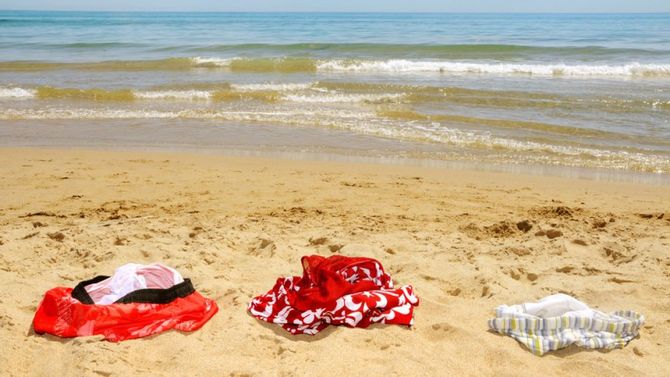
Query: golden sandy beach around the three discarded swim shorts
0 149 670 376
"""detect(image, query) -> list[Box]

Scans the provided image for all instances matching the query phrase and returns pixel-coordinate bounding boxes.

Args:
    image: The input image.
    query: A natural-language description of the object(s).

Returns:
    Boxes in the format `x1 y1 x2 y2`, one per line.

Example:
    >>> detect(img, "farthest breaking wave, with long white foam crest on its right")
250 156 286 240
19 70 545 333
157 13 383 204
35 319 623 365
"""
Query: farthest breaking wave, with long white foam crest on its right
0 57 670 78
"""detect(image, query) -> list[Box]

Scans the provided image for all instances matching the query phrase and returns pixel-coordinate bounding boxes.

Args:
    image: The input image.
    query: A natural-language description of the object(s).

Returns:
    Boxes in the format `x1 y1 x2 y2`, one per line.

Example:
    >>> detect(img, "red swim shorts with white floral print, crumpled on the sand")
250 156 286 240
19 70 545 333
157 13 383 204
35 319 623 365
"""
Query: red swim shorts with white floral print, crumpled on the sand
248 255 419 335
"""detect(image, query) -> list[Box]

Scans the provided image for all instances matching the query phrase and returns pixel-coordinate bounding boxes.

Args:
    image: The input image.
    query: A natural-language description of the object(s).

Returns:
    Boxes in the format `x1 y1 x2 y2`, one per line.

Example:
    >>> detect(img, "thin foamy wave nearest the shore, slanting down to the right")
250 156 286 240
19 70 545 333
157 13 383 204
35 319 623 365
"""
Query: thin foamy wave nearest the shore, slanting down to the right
0 108 670 173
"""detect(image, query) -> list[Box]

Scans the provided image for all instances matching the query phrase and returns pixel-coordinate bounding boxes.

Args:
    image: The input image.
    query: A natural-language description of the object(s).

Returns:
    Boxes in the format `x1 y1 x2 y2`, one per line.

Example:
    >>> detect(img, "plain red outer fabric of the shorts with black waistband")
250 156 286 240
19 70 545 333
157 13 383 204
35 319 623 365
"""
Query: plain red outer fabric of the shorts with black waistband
33 287 219 342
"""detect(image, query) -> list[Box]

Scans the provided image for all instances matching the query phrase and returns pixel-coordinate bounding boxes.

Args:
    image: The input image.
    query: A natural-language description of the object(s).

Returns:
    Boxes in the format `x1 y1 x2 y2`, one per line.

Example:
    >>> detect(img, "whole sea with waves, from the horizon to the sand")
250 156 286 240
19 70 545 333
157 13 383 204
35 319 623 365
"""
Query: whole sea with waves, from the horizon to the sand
0 11 670 177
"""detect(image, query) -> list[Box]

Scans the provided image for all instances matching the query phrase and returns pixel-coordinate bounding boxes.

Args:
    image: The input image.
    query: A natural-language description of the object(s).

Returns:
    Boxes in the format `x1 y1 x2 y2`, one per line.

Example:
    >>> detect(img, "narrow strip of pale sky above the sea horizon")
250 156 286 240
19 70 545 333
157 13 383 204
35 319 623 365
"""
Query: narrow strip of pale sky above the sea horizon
0 0 670 13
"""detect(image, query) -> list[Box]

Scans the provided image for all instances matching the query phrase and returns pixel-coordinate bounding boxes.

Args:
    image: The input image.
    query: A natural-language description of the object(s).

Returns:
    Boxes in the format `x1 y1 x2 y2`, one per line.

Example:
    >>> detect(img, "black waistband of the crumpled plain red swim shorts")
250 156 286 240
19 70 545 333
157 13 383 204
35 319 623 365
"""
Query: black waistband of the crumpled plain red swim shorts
72 276 195 305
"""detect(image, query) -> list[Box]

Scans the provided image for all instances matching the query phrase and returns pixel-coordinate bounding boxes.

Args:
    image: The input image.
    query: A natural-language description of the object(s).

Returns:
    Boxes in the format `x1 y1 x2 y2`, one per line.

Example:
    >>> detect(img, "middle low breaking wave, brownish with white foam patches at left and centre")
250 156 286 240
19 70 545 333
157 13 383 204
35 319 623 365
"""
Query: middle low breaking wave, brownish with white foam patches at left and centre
0 81 670 113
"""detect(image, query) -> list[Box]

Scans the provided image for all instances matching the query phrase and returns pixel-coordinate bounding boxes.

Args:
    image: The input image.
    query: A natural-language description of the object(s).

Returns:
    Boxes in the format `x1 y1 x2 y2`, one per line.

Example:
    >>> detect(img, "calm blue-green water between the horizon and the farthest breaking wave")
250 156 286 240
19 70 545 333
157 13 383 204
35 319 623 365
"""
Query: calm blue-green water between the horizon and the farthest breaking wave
0 12 670 64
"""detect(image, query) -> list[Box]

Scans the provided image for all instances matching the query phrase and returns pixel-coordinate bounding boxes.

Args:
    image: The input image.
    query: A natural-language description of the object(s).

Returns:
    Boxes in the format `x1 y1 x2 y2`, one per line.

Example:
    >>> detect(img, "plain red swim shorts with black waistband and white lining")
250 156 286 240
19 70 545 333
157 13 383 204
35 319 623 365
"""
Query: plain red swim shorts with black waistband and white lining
33 263 218 342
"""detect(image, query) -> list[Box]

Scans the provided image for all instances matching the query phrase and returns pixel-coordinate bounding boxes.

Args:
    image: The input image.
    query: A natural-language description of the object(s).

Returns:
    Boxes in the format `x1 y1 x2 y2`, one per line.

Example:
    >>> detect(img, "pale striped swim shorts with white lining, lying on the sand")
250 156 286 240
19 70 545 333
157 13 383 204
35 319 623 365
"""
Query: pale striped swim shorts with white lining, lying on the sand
489 294 644 356
